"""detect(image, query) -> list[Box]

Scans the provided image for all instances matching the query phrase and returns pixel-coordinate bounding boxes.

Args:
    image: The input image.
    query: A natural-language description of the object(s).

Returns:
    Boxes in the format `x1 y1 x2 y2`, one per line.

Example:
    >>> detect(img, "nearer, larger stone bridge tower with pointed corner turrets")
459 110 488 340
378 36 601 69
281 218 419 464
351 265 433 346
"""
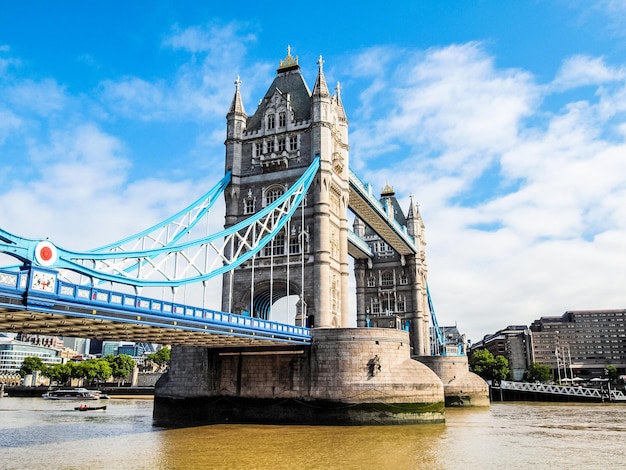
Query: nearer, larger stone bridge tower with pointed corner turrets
222 49 349 327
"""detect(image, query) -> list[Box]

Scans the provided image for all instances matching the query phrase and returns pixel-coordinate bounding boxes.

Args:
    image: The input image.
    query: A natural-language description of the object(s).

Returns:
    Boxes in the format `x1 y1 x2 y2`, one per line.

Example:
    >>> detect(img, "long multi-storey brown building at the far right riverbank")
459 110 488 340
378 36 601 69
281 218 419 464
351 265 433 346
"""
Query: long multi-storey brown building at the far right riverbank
530 309 626 379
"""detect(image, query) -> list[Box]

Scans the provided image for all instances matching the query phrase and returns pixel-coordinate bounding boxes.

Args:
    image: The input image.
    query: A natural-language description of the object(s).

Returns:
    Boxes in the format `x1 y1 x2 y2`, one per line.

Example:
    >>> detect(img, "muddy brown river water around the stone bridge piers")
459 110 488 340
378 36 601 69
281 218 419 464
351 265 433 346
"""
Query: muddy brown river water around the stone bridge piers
0 397 626 470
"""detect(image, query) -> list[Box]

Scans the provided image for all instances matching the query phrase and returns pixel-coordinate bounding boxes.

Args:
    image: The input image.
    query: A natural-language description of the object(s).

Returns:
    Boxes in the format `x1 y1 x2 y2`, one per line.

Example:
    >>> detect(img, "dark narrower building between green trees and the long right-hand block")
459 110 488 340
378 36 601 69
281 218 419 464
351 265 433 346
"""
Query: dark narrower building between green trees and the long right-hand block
471 325 534 380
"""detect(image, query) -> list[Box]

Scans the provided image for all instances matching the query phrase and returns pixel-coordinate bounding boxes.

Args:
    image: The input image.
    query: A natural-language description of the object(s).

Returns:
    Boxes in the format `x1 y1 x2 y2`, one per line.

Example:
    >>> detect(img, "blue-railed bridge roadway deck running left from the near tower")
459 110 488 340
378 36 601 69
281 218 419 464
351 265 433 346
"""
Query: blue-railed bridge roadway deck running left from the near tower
0 267 311 347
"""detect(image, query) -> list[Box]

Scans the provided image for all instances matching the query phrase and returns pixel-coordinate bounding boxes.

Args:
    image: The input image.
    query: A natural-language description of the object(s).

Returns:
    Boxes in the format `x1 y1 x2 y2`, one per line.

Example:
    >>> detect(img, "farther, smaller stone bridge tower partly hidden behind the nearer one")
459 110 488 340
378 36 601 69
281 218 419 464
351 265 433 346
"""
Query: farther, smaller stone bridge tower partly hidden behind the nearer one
353 184 431 356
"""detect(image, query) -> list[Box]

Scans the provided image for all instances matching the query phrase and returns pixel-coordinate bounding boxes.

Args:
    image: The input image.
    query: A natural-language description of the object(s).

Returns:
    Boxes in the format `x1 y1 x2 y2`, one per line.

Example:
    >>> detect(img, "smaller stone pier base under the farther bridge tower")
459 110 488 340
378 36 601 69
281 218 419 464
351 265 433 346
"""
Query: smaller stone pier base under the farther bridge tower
416 356 489 407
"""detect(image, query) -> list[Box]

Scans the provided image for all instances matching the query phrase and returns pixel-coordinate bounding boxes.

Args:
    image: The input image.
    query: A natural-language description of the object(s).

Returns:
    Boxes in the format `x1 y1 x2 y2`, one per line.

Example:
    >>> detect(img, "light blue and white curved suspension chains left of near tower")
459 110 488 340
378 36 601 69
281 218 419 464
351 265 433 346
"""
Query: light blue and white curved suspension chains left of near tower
0 157 319 287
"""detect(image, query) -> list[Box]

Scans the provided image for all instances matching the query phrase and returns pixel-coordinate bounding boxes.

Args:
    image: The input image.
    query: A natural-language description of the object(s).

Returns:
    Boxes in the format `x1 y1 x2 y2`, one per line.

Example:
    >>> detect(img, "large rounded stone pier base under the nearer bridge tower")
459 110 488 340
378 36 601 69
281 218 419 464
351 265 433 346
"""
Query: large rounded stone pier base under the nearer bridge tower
154 328 445 426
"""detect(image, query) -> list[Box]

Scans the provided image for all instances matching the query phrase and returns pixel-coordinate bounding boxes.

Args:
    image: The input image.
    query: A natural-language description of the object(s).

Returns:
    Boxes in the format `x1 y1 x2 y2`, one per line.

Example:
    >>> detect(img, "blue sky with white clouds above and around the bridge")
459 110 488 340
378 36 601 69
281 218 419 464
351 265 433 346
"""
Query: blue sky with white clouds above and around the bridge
0 0 626 340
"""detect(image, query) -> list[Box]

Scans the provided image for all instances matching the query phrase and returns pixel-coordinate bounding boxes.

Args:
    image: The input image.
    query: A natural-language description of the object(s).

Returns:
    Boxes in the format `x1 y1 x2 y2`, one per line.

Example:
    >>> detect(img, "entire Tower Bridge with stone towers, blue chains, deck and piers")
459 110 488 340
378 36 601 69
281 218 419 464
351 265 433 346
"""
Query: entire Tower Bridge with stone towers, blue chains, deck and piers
0 52 488 424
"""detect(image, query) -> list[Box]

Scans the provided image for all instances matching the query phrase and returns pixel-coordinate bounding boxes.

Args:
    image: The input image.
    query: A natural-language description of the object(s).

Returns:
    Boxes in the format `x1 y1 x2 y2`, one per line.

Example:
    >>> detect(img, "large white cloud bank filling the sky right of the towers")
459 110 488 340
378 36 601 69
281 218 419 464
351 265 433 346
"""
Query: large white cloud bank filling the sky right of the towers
348 43 626 340
